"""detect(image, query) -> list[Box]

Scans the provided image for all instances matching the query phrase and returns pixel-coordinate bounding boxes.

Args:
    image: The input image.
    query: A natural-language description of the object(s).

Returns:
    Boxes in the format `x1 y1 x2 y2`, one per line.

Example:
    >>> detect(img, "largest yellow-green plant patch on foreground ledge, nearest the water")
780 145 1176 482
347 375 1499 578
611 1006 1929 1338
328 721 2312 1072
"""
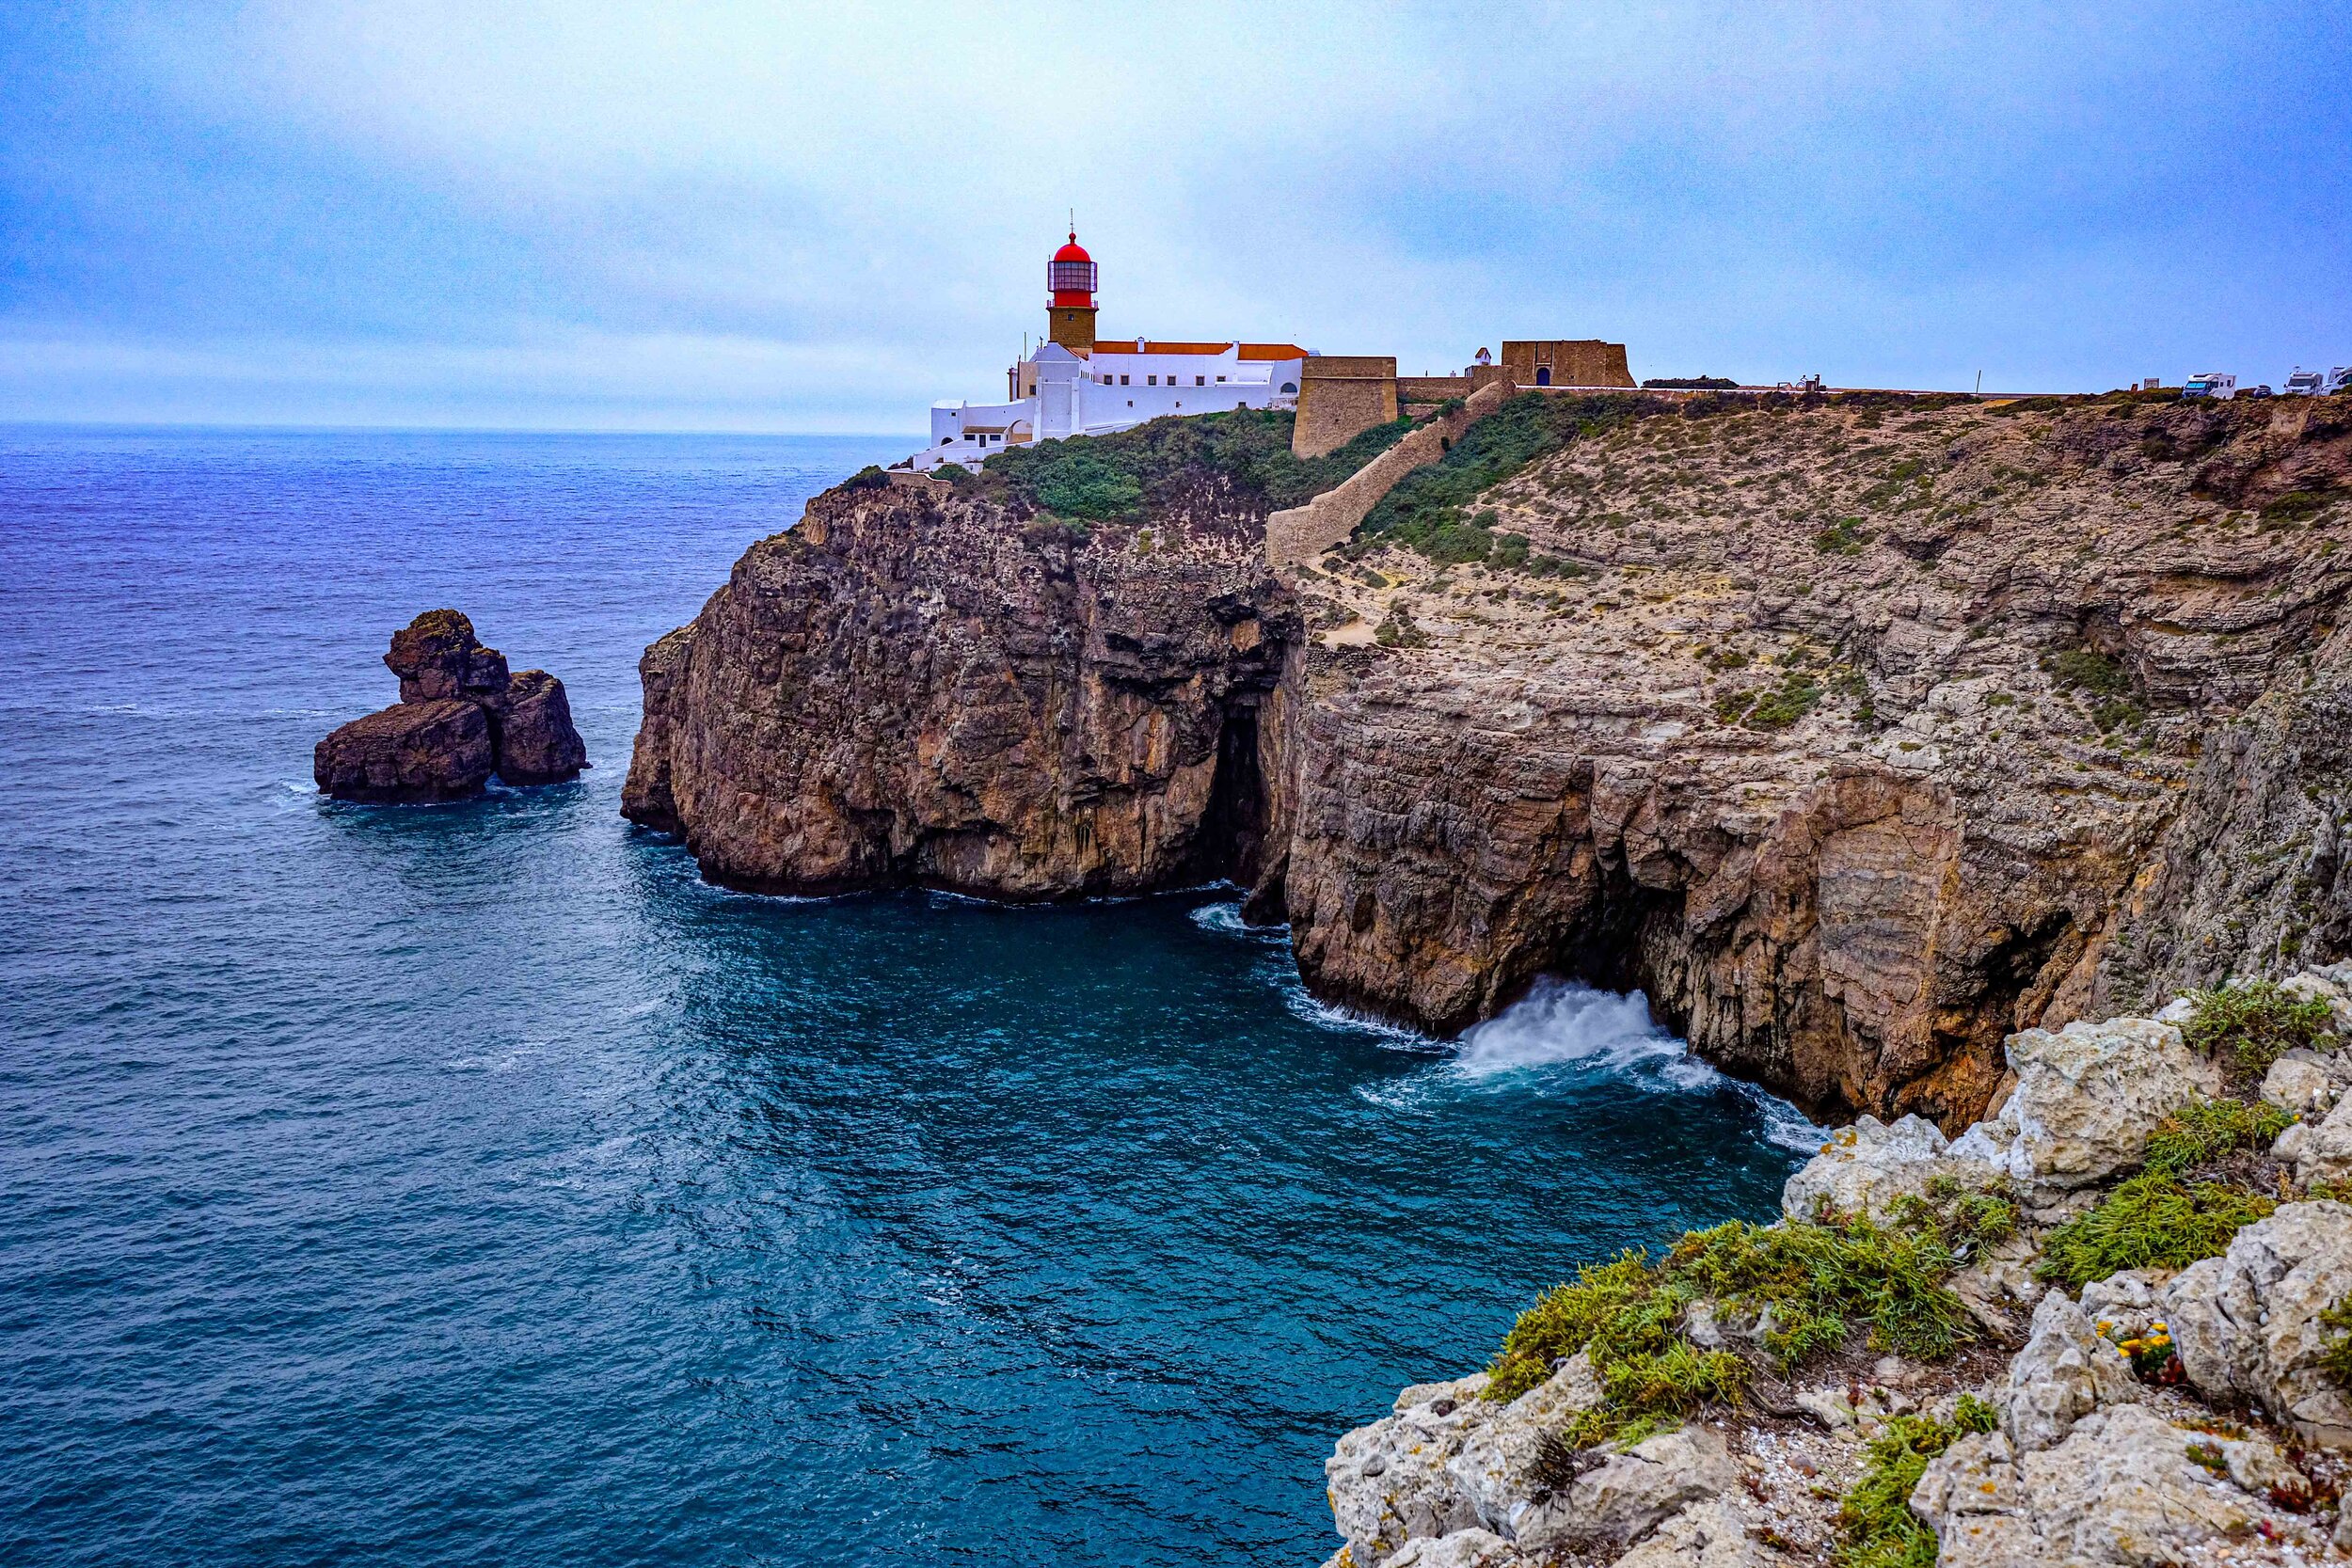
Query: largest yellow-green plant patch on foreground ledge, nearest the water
1486 1220 1974 1449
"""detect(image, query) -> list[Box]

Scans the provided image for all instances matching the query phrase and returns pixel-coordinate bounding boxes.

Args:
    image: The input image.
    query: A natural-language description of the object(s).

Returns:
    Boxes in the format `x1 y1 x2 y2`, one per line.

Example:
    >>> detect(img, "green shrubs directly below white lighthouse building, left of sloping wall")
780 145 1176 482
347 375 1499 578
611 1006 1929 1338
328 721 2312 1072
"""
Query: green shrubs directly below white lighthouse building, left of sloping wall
981 409 1414 522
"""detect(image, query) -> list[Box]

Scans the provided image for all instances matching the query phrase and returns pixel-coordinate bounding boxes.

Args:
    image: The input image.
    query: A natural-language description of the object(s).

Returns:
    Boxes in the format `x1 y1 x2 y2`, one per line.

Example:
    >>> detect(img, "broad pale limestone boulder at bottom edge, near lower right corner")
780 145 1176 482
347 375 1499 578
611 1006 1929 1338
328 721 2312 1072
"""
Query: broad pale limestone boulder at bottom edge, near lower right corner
1910 1403 2308 1568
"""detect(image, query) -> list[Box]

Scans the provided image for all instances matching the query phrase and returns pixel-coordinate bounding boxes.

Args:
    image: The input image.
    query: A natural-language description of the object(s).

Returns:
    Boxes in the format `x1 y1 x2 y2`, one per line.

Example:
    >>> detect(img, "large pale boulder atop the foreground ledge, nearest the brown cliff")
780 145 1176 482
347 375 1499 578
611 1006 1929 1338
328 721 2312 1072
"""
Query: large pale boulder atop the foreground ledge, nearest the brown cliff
1950 1018 2223 1201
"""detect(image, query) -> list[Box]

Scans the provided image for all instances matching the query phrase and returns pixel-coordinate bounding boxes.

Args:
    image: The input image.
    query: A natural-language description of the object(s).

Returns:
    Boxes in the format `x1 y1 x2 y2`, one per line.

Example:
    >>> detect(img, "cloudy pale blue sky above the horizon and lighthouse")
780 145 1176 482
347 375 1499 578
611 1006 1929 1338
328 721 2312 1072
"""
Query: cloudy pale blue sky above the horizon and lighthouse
0 0 2352 433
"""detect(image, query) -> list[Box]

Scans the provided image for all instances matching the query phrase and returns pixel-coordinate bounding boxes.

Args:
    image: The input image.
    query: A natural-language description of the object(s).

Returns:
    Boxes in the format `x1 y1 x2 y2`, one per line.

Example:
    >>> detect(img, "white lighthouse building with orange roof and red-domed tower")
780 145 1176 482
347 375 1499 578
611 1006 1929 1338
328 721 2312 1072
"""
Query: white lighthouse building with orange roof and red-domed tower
908 232 1308 467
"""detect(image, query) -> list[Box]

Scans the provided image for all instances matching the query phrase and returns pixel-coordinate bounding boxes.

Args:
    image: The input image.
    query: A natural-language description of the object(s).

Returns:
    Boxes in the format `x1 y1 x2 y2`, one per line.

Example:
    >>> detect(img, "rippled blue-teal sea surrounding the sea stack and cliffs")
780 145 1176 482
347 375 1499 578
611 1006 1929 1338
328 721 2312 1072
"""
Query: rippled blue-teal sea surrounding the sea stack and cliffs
0 430 1809 1563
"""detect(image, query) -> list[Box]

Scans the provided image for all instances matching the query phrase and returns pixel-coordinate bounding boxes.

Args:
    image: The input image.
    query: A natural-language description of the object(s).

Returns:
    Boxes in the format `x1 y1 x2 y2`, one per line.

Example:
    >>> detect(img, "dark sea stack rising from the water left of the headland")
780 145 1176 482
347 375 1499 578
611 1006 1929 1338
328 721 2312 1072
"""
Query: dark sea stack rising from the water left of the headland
313 609 588 801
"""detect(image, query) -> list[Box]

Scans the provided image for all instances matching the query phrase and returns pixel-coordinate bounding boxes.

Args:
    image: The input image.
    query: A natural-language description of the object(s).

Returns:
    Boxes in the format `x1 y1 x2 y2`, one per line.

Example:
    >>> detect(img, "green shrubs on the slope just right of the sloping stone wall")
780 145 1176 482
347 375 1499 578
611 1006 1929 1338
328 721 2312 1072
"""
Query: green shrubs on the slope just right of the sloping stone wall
1358 392 1656 564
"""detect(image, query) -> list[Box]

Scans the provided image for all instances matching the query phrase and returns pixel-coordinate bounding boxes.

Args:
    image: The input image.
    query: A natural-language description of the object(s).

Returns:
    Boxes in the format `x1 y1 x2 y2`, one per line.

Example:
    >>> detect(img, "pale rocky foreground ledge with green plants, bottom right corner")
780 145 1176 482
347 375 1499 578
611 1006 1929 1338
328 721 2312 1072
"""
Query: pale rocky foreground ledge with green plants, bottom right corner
1325 964 2352 1568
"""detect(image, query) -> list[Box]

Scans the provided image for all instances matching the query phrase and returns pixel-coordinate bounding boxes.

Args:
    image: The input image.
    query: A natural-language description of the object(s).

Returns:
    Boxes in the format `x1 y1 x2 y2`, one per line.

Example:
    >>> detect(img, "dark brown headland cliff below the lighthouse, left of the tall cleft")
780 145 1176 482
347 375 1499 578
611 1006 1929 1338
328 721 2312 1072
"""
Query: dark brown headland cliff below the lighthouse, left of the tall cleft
624 482 1301 898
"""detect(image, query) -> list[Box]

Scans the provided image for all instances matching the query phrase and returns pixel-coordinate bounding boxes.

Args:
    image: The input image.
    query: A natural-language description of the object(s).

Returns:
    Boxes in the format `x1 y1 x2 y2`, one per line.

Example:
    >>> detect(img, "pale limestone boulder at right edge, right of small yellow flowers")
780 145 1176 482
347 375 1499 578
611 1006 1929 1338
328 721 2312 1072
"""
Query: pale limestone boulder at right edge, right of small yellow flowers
2164 1201 2352 1449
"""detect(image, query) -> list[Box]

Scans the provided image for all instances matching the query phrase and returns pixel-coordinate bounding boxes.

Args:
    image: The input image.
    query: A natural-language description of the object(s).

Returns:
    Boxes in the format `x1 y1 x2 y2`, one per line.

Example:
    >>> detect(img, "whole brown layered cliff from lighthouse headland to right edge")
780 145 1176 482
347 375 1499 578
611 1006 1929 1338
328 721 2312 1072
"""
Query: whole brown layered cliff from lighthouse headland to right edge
628 400 2352 1126
